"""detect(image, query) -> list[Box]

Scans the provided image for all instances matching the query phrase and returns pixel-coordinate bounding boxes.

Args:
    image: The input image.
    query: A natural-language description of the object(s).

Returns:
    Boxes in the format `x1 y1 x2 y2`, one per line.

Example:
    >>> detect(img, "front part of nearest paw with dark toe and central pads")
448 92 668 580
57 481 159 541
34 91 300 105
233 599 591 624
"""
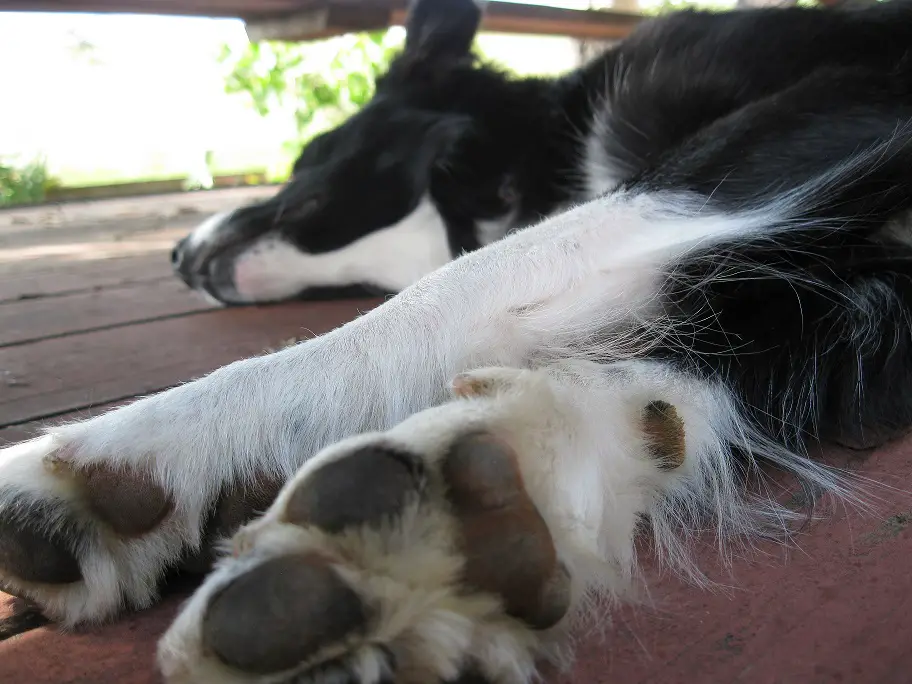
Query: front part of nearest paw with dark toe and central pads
160 431 570 684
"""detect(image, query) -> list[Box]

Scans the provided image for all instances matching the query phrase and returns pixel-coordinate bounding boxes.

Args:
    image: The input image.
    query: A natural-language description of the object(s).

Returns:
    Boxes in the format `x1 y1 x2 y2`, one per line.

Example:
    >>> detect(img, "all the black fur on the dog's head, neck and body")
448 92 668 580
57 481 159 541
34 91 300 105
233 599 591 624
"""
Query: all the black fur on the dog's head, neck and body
176 0 912 454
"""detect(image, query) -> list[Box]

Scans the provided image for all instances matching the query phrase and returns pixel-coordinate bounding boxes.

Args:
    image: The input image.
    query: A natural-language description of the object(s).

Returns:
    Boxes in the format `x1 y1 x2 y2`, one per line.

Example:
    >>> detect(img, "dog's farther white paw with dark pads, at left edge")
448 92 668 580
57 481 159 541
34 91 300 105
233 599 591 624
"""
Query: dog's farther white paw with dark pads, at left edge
0 405 282 626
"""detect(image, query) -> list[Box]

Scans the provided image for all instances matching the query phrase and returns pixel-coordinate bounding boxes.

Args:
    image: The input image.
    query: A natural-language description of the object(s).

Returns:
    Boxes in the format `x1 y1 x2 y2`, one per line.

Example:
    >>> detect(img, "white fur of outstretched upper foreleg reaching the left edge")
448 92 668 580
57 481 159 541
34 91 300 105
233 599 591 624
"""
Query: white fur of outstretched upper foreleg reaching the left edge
0 183 848 624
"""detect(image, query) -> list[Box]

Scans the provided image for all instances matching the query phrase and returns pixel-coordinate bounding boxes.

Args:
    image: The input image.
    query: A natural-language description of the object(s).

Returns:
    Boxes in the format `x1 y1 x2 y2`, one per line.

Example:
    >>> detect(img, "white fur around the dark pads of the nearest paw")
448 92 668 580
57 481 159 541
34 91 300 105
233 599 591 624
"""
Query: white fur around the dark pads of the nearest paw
159 361 828 684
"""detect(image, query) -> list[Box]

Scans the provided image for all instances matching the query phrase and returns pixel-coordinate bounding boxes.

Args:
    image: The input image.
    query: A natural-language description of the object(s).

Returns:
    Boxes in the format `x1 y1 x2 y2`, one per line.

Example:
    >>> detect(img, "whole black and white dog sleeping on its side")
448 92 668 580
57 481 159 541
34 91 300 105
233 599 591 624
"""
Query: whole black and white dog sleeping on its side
0 0 912 684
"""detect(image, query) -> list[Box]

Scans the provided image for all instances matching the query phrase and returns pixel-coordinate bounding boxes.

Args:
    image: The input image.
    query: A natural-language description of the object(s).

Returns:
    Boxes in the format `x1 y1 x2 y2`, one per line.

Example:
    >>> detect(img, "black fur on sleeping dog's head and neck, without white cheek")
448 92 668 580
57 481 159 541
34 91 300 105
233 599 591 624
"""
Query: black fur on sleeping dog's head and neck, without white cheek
172 0 586 303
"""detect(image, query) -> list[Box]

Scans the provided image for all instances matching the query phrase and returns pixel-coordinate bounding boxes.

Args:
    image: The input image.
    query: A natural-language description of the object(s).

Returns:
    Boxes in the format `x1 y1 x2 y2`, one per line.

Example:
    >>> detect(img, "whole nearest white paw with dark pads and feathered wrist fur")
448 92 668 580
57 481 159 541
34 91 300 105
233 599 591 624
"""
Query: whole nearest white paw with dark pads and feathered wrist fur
159 362 775 684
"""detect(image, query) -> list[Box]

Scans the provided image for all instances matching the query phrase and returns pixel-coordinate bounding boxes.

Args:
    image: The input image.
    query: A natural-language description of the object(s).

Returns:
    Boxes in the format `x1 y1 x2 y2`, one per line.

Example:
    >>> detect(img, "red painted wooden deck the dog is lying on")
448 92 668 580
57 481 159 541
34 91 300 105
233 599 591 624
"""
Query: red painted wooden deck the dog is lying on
0 190 912 684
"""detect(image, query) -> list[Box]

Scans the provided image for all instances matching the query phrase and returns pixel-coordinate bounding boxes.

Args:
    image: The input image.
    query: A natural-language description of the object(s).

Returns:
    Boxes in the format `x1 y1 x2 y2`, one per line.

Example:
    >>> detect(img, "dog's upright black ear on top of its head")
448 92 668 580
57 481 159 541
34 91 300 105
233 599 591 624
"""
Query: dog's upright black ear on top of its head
405 0 487 59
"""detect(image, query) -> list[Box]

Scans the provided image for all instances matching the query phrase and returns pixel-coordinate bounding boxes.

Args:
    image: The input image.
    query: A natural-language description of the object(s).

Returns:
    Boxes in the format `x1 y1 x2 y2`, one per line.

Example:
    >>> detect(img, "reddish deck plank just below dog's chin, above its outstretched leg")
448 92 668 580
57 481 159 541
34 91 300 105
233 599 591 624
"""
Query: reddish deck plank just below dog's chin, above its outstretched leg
0 299 379 427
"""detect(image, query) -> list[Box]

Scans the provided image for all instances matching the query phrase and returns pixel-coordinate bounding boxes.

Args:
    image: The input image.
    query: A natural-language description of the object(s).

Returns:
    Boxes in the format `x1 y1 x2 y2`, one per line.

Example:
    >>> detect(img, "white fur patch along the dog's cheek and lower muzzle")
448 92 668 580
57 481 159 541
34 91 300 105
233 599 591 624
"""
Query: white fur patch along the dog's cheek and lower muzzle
234 198 452 301
